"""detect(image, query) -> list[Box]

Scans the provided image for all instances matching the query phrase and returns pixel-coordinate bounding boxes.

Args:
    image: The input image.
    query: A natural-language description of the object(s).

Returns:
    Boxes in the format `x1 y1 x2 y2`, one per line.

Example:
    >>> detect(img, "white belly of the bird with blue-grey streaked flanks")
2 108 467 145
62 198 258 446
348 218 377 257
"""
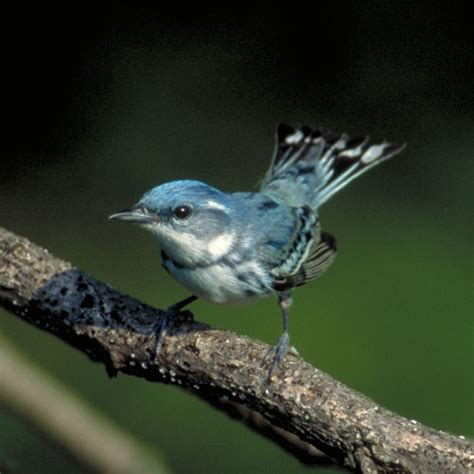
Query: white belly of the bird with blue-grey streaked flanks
165 260 273 304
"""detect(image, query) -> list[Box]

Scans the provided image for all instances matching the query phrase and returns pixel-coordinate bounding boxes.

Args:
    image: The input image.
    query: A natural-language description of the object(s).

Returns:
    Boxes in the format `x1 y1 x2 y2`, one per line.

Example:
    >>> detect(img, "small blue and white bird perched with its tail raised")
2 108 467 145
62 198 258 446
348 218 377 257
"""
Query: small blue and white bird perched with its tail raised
110 123 405 380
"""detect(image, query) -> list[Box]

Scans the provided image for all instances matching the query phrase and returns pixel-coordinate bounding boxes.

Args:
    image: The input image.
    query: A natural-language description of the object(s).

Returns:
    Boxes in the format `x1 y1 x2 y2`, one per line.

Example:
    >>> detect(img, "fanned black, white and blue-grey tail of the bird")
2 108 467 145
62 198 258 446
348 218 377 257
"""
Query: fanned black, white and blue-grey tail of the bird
261 124 405 209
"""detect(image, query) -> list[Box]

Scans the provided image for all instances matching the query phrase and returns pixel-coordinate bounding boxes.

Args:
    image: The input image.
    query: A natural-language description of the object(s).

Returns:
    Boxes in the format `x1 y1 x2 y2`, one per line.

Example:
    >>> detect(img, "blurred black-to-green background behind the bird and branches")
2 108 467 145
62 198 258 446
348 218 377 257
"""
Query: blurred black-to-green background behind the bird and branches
0 1 474 473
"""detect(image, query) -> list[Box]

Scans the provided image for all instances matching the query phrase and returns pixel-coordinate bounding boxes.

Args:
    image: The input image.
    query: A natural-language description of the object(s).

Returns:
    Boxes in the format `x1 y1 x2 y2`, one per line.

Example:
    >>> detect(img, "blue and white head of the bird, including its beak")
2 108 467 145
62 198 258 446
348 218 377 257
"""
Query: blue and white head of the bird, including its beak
110 180 234 265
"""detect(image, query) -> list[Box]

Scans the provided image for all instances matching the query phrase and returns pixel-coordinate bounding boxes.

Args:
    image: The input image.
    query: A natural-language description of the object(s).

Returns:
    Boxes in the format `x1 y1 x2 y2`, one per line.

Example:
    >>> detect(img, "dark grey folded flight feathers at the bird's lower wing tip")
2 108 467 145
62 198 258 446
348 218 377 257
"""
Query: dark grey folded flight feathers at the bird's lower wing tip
273 232 337 291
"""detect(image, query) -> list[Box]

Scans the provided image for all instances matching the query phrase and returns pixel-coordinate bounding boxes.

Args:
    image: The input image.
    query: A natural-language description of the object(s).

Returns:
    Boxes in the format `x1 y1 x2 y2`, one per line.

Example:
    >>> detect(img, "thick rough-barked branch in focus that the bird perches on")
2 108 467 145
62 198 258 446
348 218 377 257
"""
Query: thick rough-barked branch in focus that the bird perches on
0 228 474 472
